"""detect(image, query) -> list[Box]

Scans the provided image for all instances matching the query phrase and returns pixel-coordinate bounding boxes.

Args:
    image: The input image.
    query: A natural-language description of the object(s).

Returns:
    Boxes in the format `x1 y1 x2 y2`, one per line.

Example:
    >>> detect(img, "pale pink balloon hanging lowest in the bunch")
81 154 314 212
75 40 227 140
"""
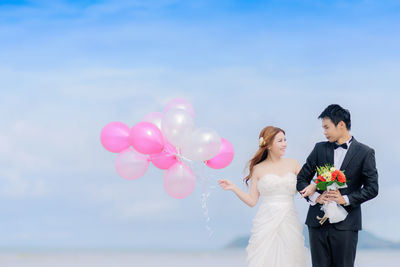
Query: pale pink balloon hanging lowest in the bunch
164 162 196 199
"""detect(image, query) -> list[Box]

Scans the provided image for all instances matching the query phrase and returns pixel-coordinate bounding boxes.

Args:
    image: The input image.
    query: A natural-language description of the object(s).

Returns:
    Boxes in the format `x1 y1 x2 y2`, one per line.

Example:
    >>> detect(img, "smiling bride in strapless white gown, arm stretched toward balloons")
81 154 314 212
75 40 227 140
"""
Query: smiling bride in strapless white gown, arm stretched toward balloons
218 126 316 267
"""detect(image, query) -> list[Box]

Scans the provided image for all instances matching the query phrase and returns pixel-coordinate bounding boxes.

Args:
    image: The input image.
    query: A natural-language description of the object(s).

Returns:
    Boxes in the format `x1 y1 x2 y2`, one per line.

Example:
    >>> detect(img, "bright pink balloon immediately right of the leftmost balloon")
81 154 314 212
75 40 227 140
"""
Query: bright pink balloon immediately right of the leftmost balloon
131 121 164 154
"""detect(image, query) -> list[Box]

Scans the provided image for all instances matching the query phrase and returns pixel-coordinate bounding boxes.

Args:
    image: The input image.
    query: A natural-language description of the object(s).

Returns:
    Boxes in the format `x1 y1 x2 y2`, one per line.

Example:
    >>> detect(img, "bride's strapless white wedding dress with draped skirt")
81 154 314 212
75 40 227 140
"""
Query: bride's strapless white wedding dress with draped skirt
246 173 307 267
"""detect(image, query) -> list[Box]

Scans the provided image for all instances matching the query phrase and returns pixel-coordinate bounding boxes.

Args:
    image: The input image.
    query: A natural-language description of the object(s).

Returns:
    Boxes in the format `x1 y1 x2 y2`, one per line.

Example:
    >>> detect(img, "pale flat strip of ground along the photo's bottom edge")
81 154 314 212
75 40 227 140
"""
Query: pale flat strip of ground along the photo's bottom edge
0 250 400 267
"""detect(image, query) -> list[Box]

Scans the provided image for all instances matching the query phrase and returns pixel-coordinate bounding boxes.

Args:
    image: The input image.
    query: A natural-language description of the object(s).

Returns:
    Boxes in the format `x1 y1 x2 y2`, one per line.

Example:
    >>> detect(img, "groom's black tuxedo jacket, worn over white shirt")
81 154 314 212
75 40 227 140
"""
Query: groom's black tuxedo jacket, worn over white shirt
297 138 378 231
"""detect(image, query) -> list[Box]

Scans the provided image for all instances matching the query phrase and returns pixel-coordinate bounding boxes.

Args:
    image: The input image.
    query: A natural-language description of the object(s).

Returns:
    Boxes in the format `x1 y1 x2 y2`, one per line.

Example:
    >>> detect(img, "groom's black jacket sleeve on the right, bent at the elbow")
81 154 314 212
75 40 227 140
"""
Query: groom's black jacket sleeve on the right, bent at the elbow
348 149 379 207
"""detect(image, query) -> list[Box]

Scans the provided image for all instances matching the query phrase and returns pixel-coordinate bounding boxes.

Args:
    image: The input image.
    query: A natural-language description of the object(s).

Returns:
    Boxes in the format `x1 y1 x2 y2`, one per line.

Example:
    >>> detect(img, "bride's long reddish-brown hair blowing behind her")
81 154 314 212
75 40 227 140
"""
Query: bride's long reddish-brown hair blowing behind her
243 126 286 185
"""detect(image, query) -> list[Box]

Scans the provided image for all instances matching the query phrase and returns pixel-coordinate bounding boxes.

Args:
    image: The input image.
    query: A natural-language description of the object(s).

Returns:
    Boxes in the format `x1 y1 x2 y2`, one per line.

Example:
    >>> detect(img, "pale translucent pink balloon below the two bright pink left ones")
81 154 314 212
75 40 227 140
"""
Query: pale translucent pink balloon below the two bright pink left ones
115 147 149 180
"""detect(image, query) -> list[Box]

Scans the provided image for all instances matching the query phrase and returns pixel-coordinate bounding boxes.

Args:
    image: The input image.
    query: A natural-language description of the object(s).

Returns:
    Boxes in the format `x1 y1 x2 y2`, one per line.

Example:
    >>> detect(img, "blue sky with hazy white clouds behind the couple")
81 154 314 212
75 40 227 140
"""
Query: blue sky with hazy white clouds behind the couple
0 0 400 249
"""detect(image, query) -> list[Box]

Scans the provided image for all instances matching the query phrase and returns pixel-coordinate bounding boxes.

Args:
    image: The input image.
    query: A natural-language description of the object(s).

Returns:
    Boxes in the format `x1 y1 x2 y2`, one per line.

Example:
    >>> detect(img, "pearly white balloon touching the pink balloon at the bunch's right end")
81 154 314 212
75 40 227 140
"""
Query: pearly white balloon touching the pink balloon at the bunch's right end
182 128 221 161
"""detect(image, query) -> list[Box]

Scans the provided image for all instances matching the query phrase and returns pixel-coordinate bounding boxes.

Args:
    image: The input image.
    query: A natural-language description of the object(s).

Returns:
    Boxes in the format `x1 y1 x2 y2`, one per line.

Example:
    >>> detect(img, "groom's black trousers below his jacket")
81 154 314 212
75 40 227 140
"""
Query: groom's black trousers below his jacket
308 225 358 267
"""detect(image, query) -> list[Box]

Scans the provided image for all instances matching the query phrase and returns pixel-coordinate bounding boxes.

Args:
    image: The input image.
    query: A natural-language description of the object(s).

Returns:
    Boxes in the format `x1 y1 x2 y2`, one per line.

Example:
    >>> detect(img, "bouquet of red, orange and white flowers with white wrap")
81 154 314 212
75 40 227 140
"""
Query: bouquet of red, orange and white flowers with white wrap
314 165 348 225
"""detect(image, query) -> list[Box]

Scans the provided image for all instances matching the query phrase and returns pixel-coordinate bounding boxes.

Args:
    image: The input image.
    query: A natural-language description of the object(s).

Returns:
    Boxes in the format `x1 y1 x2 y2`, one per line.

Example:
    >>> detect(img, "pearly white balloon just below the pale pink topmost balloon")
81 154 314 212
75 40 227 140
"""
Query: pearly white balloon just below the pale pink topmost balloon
161 108 194 148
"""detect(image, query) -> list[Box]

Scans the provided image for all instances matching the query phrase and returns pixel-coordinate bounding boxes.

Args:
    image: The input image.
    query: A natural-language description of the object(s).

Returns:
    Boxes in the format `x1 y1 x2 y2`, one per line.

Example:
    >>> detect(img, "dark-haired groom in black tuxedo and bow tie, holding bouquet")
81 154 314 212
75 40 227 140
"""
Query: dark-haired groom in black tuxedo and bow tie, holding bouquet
297 105 378 267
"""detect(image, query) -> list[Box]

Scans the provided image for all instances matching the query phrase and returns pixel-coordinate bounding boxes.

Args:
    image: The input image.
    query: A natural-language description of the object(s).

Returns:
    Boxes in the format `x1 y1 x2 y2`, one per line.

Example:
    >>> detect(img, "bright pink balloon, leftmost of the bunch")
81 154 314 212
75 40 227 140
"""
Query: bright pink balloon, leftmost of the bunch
100 122 130 153
